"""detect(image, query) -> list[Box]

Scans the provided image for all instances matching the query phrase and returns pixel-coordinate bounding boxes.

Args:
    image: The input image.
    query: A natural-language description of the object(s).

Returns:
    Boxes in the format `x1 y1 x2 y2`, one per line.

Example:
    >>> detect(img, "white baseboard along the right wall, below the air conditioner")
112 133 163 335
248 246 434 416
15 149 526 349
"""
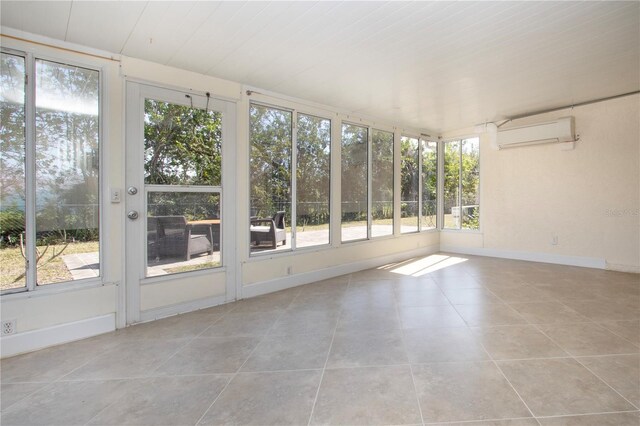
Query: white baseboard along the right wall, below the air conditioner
440 245 607 269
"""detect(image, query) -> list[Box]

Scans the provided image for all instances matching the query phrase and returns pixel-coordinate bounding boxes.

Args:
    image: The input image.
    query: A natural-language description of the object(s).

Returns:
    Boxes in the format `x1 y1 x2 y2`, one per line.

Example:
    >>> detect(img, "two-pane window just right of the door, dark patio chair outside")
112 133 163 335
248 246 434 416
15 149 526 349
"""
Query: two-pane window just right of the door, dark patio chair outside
249 103 331 253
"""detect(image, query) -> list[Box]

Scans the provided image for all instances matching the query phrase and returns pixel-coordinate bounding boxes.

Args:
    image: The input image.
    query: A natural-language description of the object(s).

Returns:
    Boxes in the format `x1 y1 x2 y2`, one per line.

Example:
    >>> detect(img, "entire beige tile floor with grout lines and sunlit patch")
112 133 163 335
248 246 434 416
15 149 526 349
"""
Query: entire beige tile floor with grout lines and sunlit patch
0 254 640 426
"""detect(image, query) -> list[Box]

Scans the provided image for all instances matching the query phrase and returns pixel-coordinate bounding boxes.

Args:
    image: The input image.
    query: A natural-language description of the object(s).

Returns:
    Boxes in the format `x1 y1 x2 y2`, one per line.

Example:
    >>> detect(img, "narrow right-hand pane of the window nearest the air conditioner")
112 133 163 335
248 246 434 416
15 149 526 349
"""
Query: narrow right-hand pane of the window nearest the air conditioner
462 138 480 229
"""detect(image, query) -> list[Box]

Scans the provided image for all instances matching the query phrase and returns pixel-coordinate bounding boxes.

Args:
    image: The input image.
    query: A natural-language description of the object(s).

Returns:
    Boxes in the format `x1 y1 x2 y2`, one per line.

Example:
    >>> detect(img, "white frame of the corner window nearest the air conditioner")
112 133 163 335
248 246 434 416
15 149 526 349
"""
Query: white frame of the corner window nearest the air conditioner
436 134 483 234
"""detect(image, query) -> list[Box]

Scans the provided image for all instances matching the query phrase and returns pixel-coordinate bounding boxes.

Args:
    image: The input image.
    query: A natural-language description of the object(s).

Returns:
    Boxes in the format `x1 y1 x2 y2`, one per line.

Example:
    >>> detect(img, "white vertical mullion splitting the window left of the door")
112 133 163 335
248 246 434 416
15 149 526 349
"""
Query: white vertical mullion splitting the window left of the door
25 54 37 291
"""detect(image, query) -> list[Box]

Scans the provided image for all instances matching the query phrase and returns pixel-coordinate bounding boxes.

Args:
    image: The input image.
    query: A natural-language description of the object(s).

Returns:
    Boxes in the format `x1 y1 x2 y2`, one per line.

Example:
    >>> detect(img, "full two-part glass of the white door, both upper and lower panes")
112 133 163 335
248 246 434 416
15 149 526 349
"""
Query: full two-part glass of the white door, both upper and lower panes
144 98 222 277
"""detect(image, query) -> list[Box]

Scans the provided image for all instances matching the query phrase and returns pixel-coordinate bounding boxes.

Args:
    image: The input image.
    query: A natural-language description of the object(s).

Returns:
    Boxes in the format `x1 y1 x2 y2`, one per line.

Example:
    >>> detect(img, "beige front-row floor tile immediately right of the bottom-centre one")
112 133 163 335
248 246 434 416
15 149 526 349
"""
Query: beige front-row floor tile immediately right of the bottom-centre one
412 362 531 423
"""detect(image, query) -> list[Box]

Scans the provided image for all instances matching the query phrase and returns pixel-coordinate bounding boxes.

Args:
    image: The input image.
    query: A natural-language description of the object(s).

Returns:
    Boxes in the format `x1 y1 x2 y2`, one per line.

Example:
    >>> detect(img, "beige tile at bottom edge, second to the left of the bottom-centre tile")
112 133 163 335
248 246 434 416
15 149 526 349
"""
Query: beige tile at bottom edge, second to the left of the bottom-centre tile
88 375 231 425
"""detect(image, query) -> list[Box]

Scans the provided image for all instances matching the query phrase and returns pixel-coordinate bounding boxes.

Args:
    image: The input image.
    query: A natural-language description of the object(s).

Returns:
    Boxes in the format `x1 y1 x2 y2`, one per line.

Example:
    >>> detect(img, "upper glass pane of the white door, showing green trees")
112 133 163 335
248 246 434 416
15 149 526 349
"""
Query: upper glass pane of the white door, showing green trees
144 99 222 186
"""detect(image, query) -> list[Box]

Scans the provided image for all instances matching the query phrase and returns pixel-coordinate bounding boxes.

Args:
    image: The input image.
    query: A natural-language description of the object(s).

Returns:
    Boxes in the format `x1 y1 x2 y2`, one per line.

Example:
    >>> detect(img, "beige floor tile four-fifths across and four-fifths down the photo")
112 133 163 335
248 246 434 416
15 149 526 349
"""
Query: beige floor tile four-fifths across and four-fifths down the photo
473 325 568 359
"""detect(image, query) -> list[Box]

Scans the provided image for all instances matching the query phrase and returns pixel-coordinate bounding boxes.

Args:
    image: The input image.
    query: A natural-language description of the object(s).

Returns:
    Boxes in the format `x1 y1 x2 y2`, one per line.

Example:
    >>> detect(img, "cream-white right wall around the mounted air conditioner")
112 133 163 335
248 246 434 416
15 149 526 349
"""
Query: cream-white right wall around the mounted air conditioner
441 95 640 272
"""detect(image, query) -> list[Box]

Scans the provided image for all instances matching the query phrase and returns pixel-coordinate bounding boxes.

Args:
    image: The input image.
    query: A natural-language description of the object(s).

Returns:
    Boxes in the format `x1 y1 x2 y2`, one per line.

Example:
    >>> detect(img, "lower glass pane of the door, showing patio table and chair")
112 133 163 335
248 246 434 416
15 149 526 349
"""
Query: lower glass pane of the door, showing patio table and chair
147 192 221 277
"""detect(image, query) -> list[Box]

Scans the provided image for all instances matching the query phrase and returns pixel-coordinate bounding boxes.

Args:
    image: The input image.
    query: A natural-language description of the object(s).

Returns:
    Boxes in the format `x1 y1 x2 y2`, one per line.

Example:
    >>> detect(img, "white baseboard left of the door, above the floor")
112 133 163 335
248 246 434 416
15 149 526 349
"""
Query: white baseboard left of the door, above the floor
0 313 116 358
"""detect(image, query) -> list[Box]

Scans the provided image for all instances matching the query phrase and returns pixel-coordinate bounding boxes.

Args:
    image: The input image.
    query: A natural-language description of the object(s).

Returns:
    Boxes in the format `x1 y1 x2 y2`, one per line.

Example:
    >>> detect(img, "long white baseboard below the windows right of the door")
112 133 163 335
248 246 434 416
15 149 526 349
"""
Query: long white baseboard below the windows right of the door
242 245 439 299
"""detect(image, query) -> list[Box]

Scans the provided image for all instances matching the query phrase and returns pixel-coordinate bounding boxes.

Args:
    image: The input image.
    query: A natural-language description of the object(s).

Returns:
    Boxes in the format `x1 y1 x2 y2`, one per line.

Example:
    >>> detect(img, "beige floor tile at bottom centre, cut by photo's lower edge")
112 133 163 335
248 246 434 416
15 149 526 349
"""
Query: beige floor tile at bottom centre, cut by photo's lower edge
311 366 421 425
